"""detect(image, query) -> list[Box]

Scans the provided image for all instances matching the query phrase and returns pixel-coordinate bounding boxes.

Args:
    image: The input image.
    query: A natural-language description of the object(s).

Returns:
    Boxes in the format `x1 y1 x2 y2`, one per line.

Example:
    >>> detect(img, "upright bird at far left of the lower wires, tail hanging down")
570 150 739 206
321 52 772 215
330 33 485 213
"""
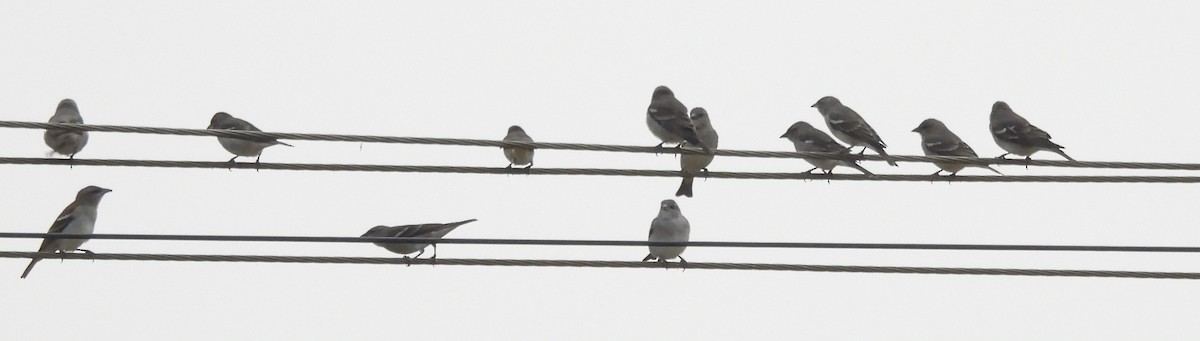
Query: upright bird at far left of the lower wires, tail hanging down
20 186 113 279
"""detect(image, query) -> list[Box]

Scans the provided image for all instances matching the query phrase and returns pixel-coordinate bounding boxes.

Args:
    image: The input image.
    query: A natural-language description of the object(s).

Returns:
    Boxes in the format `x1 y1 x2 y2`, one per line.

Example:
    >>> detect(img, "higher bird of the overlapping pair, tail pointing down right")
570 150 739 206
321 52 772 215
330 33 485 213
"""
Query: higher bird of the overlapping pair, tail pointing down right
812 96 898 166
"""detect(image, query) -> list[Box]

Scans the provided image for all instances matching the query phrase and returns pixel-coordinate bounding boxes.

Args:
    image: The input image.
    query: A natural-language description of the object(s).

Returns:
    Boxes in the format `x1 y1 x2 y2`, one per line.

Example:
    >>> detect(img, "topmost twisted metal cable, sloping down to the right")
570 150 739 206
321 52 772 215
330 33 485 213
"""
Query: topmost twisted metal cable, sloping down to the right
0 121 1200 171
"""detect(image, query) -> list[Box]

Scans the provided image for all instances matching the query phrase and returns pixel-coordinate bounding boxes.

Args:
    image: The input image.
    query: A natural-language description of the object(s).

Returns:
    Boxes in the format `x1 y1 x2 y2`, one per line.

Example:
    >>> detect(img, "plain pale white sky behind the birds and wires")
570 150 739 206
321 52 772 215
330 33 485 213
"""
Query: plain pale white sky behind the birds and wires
0 1 1200 340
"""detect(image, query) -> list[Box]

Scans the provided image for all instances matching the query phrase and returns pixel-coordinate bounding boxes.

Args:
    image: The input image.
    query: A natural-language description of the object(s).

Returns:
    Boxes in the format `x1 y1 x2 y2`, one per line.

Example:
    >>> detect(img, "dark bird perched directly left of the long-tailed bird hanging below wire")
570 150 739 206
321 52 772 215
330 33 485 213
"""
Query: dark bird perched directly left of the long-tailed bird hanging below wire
646 85 713 154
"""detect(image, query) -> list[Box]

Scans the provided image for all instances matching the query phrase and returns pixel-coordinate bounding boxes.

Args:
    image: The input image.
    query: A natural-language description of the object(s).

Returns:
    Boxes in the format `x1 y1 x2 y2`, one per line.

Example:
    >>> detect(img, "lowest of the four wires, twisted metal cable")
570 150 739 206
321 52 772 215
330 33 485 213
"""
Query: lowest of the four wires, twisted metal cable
0 251 1200 280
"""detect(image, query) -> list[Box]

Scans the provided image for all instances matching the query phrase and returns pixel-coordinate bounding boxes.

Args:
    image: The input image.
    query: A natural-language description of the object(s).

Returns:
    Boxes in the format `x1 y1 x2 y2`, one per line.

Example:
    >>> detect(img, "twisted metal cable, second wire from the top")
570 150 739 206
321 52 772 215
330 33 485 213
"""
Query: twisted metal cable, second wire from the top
0 157 1200 184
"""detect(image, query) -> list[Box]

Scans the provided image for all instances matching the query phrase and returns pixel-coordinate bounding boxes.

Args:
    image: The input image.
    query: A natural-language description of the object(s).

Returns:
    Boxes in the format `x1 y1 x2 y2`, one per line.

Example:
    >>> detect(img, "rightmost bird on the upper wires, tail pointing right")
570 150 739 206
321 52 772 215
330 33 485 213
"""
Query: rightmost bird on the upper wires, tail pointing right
988 101 1075 161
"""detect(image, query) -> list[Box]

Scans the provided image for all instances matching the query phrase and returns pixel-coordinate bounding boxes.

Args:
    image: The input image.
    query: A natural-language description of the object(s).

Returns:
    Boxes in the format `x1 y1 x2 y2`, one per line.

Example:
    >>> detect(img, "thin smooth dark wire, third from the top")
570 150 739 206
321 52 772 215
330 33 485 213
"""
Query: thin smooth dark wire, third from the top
0 232 1200 252
